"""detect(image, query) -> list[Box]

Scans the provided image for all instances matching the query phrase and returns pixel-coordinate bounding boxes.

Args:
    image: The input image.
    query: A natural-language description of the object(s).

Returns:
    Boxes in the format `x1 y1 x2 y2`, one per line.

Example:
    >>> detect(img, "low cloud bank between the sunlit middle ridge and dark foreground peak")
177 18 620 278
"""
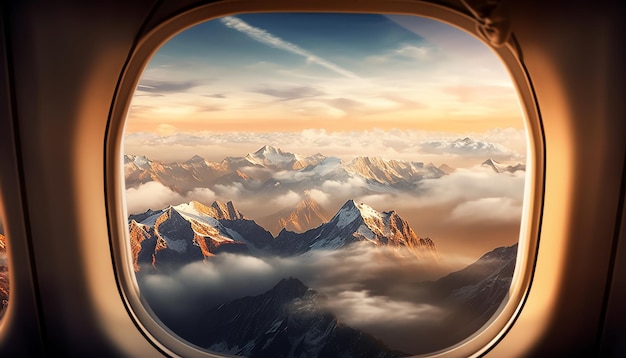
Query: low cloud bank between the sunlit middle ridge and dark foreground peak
138 245 456 352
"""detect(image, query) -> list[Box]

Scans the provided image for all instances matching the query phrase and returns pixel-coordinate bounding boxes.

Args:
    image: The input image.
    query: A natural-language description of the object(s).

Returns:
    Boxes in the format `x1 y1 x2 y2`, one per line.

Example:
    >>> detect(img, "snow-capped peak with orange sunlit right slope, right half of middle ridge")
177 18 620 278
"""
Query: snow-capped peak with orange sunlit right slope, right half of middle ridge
272 200 438 259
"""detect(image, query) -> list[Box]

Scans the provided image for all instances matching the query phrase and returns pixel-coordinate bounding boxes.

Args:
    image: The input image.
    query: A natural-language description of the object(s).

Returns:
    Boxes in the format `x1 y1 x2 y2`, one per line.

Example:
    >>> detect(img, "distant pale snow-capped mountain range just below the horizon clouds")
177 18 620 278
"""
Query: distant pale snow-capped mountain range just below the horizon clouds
124 145 445 195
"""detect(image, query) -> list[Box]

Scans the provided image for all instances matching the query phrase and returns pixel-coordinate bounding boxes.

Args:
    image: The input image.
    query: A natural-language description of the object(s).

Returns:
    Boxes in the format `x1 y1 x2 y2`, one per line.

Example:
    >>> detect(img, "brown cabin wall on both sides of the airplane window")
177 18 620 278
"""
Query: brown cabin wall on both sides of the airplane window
0 0 626 357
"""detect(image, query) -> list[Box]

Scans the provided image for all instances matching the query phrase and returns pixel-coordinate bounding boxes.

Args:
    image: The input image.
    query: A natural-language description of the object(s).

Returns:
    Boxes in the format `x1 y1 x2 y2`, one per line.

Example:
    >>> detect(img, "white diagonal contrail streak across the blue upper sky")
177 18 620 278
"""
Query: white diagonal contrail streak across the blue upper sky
220 16 359 78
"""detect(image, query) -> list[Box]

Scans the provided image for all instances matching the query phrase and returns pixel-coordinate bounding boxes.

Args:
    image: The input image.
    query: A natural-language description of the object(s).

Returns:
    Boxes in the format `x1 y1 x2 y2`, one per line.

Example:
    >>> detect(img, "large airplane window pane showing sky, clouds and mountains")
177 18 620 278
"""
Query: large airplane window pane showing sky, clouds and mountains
123 13 528 357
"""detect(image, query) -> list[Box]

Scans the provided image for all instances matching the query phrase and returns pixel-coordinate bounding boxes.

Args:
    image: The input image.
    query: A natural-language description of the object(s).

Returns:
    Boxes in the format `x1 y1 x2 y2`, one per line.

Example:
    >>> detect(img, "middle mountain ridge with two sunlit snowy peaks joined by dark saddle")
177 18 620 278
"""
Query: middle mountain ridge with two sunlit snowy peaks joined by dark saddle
128 200 438 271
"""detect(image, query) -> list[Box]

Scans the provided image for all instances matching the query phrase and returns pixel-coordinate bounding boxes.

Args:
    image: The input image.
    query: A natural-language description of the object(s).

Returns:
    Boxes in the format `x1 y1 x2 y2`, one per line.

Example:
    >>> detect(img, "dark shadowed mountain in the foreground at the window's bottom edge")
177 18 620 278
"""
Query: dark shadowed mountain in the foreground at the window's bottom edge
184 278 398 358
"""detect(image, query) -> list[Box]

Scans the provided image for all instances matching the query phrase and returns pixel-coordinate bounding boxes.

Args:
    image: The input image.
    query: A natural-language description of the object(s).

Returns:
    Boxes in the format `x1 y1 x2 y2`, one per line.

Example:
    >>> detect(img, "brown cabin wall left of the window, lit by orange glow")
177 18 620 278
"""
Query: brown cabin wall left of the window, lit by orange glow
0 1 165 356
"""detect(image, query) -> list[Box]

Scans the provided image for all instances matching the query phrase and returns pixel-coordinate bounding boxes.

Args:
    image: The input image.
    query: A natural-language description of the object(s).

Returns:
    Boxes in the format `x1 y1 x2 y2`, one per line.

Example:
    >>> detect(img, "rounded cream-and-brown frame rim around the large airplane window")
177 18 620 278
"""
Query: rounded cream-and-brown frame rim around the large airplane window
104 0 545 357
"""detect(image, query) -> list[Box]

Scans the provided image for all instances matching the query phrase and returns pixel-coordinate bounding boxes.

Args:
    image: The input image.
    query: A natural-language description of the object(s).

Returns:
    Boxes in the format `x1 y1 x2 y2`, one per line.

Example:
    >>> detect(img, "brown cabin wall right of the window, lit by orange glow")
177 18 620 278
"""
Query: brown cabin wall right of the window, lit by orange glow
492 1 626 356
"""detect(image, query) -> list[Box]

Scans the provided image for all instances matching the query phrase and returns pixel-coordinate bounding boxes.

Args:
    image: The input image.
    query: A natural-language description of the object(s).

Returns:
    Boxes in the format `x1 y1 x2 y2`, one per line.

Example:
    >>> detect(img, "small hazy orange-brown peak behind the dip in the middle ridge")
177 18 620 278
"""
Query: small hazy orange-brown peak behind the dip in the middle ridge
257 197 330 235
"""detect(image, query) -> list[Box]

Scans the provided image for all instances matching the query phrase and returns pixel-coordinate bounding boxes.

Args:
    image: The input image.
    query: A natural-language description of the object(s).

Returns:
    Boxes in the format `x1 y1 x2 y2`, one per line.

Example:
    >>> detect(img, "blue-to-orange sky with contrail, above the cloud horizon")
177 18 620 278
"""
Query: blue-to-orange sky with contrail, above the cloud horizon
126 13 523 141
